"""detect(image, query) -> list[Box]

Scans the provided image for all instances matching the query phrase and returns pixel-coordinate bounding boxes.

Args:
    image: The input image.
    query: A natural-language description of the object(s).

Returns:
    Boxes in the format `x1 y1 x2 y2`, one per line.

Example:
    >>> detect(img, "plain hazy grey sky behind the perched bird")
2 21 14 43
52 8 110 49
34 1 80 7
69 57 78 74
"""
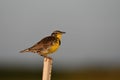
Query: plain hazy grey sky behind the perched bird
0 0 120 68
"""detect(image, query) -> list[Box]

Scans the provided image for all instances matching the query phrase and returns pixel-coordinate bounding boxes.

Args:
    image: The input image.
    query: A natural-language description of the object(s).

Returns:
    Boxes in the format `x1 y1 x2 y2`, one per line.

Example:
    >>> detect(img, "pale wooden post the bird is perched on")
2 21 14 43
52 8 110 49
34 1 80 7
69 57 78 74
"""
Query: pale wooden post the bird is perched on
42 57 52 80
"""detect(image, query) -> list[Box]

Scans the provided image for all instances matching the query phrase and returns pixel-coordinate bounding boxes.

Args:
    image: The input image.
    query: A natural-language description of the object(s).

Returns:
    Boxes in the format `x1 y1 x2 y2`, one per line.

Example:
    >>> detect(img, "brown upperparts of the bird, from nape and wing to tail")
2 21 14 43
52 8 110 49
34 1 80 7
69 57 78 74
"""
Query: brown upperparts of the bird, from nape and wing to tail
20 36 61 53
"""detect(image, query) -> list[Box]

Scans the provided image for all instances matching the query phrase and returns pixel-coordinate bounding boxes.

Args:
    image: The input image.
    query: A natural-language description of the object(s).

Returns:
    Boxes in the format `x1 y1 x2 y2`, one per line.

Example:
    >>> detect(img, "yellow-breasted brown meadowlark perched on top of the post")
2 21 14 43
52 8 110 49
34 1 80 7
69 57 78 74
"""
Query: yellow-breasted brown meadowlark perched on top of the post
20 30 65 57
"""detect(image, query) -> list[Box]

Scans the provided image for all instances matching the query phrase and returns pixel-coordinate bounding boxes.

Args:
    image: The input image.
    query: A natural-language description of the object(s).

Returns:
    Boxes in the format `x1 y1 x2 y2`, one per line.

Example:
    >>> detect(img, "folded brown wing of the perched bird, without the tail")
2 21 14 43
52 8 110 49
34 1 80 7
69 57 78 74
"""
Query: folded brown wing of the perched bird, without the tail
30 36 56 50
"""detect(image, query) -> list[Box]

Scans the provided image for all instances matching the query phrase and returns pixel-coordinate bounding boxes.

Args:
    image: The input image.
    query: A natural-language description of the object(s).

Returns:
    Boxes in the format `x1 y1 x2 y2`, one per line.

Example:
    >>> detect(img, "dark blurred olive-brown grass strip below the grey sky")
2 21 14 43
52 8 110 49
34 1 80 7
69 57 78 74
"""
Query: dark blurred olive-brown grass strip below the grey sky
0 68 120 80
